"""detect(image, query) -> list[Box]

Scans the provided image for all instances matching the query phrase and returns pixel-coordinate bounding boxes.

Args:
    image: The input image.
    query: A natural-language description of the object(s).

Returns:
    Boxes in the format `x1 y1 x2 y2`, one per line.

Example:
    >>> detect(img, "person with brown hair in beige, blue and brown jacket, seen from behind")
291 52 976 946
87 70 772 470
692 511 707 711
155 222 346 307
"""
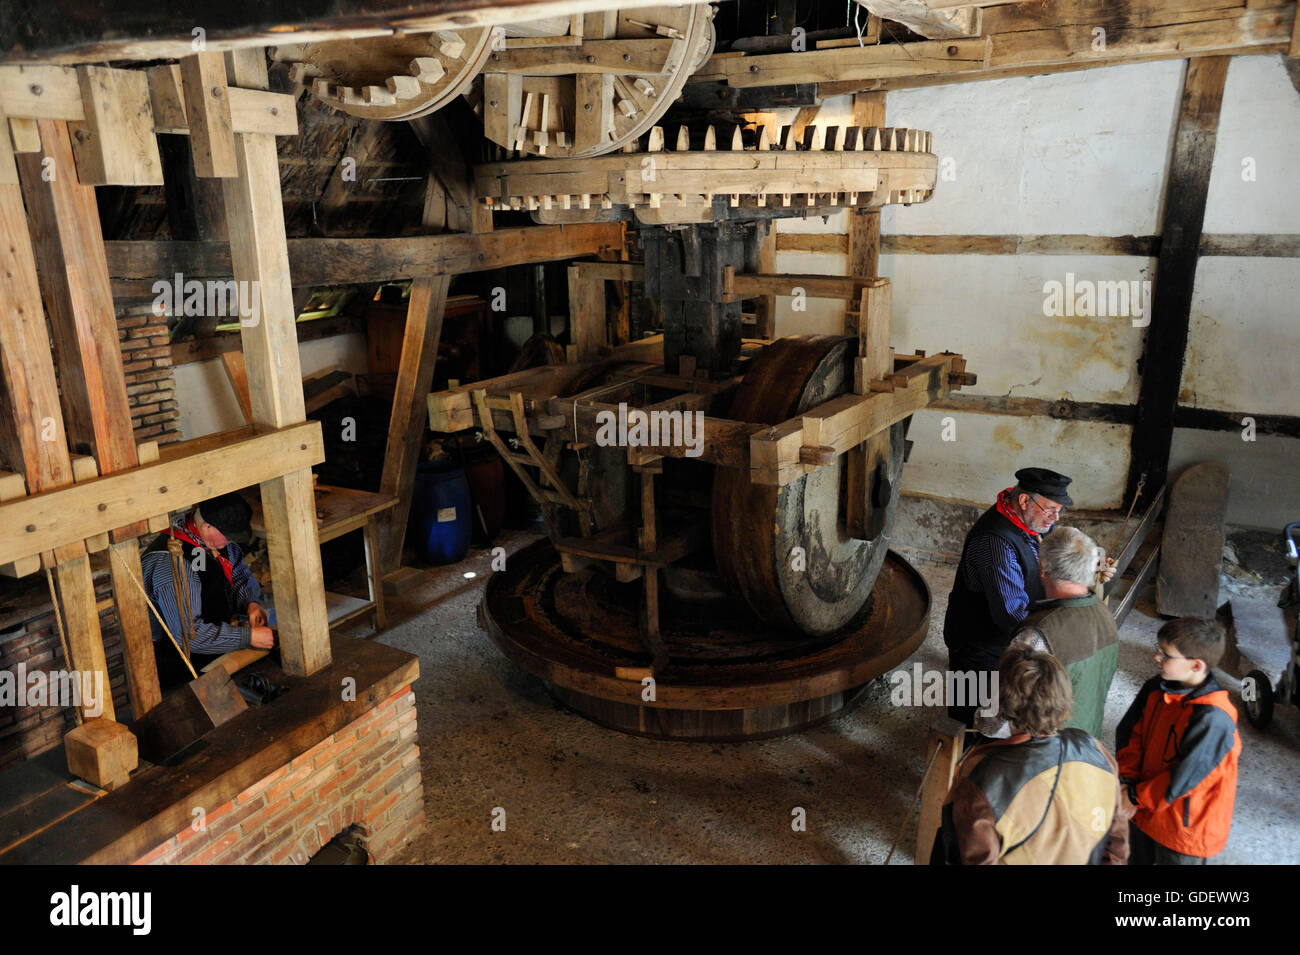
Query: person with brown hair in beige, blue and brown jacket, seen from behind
931 642 1128 865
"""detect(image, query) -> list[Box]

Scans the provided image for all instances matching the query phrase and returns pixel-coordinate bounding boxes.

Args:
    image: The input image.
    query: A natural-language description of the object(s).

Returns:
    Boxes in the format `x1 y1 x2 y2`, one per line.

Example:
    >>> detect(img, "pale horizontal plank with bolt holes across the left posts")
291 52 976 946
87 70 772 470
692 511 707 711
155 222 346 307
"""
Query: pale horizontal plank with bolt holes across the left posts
0 421 325 571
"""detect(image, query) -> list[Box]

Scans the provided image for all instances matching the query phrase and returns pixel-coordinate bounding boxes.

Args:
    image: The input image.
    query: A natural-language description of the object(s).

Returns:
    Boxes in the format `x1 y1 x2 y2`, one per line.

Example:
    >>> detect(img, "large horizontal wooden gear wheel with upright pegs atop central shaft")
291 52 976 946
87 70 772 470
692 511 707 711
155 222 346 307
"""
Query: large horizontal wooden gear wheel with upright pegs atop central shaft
475 119 939 225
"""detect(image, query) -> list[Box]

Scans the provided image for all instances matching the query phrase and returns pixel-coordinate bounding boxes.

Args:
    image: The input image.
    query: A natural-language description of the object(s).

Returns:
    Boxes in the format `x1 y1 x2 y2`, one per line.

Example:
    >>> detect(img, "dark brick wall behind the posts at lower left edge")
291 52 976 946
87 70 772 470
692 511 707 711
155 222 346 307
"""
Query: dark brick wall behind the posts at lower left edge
0 572 130 770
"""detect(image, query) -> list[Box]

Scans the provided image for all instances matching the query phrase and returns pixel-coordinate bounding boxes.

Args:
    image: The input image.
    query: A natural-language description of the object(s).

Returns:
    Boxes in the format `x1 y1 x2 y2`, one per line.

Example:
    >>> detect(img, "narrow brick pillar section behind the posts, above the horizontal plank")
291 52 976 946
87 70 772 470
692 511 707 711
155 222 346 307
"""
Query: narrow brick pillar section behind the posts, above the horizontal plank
117 303 181 444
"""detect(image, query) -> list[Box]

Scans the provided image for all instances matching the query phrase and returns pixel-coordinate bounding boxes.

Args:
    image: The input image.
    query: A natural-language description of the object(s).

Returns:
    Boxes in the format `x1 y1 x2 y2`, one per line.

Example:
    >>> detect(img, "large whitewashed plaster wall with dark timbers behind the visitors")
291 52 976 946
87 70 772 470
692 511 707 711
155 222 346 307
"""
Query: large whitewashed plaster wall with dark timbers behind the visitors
754 56 1300 528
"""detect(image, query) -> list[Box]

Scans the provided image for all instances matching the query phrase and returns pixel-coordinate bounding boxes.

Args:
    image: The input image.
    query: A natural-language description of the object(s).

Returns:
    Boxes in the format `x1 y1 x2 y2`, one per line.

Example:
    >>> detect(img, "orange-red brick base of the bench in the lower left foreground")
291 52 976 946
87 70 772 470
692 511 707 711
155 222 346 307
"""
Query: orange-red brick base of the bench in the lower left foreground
137 686 424 865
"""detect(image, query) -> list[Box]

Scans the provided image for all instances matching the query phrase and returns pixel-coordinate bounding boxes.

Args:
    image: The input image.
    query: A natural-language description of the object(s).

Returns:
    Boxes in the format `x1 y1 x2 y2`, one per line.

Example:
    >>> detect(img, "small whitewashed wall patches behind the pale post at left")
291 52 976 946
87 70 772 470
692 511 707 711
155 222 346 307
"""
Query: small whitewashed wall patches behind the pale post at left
176 334 367 439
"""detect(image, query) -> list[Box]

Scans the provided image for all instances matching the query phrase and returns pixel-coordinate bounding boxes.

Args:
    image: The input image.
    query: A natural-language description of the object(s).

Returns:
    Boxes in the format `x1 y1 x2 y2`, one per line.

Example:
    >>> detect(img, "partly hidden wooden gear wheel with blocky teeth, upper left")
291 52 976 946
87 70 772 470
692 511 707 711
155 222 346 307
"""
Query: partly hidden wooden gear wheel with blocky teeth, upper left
273 27 494 122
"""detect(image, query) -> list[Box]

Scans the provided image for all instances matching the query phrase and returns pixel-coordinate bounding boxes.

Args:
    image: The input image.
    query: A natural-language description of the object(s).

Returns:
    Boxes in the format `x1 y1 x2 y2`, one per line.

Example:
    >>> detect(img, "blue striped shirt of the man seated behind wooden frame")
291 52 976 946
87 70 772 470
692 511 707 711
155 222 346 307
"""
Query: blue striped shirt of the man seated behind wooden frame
140 515 261 655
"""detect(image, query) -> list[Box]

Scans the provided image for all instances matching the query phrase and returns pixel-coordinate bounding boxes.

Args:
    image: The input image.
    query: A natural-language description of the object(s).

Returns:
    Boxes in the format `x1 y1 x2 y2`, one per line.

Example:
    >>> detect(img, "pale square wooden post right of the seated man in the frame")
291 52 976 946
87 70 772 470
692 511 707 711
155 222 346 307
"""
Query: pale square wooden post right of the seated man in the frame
218 48 330 676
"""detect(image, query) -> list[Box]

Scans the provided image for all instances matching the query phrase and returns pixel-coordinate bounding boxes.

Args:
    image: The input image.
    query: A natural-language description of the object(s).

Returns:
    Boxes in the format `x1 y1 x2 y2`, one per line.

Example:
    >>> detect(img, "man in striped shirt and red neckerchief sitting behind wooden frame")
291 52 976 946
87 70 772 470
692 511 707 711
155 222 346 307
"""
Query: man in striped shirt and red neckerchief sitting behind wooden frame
140 494 276 689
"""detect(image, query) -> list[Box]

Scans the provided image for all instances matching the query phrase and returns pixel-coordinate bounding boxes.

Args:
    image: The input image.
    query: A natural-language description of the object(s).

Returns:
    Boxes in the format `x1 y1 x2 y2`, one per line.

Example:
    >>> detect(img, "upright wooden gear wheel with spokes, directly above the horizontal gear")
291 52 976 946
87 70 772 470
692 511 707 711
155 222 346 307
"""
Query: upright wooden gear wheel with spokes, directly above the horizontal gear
475 4 714 159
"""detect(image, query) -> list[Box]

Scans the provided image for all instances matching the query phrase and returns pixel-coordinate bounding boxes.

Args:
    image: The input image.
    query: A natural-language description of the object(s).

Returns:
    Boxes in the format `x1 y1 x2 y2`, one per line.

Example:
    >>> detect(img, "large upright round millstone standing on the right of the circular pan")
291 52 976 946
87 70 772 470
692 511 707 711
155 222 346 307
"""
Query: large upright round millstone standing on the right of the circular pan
712 335 905 635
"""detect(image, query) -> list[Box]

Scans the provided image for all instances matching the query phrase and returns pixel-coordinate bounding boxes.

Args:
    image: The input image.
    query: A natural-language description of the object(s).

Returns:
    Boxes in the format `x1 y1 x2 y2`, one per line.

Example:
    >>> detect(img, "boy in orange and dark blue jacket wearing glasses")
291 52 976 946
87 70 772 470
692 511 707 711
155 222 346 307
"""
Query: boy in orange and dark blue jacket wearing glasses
1115 617 1242 865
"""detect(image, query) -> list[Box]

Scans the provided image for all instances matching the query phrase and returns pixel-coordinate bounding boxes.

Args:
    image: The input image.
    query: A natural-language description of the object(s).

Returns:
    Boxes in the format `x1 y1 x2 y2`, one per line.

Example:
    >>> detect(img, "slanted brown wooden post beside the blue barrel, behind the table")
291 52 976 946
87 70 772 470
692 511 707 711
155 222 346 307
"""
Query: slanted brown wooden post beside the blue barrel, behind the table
377 175 451 577
